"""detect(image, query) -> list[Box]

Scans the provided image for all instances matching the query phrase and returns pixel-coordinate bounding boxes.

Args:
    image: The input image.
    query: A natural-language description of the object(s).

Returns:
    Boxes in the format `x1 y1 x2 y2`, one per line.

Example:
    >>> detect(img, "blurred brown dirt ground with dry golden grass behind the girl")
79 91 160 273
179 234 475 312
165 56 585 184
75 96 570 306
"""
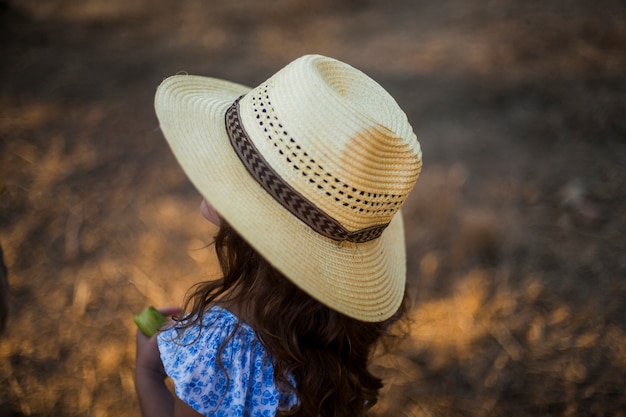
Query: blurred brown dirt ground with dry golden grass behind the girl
0 0 626 417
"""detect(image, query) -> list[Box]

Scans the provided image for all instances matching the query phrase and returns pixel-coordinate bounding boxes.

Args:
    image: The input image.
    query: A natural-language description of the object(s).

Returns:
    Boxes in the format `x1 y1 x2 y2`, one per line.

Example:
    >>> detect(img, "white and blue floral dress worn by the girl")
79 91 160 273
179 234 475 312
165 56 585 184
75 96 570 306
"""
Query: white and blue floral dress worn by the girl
158 306 297 417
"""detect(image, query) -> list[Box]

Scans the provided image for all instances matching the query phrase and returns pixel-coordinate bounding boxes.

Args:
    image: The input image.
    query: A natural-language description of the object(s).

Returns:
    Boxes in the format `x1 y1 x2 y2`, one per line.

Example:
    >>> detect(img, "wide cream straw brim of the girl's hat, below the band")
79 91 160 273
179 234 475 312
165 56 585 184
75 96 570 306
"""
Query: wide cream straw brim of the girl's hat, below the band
155 75 406 322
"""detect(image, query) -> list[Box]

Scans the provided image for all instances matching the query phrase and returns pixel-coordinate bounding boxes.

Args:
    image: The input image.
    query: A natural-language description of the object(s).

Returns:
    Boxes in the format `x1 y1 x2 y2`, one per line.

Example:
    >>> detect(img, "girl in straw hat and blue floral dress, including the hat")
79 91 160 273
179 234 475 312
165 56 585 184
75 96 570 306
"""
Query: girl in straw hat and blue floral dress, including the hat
136 55 421 417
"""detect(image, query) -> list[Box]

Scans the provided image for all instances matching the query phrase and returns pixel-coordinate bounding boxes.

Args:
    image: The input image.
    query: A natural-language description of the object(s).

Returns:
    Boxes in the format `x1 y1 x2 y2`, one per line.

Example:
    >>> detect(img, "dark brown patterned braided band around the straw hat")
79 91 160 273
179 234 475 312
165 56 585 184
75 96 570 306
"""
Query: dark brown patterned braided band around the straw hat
225 96 387 243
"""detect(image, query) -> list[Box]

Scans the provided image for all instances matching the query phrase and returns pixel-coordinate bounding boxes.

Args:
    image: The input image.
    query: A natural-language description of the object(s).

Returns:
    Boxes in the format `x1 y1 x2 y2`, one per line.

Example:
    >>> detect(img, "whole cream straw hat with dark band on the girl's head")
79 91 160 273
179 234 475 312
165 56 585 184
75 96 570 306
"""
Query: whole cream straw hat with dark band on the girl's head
155 55 421 322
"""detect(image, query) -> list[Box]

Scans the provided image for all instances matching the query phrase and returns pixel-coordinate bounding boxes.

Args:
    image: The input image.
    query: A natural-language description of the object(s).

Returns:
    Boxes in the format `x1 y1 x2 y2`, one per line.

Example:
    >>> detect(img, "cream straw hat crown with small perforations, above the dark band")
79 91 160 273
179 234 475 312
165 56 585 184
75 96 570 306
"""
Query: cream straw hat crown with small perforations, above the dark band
239 55 421 232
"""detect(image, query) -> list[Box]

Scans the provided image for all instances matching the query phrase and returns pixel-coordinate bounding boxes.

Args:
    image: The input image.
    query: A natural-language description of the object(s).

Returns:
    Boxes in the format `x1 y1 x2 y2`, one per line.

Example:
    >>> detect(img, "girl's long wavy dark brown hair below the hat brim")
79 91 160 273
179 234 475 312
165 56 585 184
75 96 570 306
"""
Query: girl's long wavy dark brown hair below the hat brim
178 220 406 417
